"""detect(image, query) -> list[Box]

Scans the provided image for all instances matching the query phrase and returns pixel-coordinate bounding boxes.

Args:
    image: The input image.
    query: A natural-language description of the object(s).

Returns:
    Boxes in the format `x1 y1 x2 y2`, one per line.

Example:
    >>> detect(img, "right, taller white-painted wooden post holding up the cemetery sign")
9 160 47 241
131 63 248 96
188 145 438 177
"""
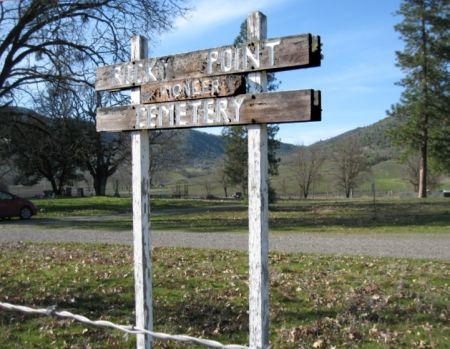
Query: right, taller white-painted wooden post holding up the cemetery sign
247 12 269 349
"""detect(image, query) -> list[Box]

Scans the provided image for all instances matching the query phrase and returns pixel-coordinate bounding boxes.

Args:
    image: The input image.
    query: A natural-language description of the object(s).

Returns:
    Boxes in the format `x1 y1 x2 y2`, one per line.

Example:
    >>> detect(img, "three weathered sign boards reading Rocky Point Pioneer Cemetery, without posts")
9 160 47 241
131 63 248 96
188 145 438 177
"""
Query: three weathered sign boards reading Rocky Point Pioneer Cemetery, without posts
95 34 321 132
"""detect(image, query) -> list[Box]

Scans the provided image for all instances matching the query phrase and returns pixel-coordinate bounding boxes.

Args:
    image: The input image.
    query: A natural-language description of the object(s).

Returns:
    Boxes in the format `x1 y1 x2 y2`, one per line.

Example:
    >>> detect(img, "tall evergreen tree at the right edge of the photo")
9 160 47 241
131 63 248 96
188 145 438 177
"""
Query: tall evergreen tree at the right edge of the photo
390 0 450 197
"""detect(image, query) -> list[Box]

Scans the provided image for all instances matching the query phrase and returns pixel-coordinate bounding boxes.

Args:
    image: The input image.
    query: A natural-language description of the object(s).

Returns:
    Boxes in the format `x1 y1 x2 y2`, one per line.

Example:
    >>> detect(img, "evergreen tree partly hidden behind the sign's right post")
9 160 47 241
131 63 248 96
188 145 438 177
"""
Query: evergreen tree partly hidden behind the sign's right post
222 21 280 201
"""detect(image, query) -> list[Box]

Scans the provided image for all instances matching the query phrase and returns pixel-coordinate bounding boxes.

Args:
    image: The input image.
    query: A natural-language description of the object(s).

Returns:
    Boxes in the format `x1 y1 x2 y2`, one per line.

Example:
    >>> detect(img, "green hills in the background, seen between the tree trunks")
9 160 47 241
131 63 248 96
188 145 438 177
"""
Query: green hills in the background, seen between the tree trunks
5 111 450 196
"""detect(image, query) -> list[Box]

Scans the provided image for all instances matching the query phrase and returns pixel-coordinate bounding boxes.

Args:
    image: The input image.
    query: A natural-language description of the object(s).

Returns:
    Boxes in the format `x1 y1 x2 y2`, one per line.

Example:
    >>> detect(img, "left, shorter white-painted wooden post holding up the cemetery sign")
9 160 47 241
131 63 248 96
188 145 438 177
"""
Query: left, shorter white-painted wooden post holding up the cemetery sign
131 36 153 349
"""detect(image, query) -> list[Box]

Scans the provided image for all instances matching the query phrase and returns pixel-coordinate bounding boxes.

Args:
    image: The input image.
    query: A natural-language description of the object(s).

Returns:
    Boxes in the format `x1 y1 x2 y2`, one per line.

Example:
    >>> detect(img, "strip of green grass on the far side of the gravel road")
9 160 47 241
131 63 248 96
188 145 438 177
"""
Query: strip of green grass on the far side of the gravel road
25 197 450 233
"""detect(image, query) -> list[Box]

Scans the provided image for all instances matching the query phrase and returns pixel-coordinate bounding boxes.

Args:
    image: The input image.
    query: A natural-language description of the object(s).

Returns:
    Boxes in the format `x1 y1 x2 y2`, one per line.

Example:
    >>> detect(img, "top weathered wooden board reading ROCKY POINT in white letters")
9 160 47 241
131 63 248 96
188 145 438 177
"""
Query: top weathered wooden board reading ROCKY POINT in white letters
95 34 321 91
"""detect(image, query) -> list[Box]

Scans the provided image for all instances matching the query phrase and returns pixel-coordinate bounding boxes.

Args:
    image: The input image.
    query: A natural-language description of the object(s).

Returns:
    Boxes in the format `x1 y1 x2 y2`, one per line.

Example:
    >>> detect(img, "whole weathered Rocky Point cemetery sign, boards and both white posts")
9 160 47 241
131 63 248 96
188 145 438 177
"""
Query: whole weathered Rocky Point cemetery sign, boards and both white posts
95 12 321 349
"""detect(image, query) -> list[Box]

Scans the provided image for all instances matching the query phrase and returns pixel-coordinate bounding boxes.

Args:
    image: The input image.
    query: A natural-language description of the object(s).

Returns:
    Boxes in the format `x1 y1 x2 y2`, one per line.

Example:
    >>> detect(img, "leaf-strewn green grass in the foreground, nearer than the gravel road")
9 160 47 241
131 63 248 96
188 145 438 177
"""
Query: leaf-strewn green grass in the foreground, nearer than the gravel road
0 244 450 349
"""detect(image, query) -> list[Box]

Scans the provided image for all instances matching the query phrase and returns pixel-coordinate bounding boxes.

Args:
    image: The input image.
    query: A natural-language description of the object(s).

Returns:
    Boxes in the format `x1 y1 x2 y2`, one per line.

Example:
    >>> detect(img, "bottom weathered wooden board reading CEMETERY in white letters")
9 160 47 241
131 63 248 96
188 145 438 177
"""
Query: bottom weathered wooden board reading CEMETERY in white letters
97 90 321 132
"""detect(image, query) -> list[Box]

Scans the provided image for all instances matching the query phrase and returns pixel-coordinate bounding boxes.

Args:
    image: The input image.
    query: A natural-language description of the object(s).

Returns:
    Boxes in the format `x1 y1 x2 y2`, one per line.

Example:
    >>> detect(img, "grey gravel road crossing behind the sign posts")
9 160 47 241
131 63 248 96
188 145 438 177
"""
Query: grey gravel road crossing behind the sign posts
0 220 450 260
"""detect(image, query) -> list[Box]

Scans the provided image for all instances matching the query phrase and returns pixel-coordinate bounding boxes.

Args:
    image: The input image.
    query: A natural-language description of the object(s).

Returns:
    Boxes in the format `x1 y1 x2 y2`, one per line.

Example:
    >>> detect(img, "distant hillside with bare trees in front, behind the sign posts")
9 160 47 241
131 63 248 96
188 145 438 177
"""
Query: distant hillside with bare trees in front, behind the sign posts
122 113 449 197
